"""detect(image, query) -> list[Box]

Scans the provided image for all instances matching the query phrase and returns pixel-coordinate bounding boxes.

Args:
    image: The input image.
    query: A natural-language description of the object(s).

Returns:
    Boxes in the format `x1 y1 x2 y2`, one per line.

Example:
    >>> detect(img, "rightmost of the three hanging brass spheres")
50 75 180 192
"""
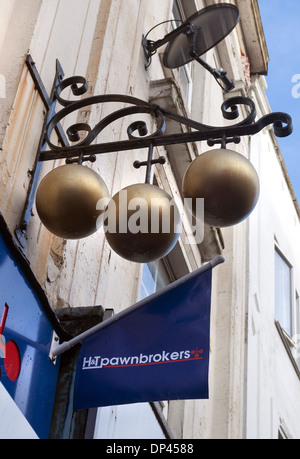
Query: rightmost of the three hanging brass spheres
183 148 260 228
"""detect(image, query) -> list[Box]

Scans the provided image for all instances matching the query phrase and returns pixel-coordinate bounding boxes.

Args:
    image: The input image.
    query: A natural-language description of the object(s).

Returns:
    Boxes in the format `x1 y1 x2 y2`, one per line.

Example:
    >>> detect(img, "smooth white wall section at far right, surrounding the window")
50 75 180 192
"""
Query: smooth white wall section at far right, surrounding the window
245 81 300 439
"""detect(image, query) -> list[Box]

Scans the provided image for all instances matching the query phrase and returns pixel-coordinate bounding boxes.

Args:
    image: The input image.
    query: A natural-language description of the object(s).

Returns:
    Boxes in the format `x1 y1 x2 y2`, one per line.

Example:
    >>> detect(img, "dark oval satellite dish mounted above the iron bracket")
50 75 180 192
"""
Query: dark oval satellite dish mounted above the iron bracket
163 3 240 69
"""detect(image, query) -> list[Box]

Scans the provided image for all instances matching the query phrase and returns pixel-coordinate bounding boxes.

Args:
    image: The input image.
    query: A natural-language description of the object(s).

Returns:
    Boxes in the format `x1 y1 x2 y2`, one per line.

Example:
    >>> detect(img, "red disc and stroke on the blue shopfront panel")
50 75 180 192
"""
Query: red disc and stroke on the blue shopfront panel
0 304 21 381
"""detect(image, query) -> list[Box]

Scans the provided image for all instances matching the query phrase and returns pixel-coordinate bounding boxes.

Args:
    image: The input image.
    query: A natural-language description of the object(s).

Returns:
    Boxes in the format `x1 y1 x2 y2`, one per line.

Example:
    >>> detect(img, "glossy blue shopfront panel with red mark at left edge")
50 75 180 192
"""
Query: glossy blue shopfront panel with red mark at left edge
0 215 64 438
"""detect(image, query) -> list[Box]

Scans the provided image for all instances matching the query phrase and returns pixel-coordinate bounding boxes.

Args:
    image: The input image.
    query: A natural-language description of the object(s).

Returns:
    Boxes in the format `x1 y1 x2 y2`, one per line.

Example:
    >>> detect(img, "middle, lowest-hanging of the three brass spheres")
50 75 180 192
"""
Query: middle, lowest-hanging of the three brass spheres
104 183 181 263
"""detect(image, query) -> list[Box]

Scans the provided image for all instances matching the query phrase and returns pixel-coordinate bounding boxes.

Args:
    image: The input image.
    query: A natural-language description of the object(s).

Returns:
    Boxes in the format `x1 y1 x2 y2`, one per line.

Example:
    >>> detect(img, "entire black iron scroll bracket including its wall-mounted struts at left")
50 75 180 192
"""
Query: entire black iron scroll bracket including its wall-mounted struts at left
16 55 293 247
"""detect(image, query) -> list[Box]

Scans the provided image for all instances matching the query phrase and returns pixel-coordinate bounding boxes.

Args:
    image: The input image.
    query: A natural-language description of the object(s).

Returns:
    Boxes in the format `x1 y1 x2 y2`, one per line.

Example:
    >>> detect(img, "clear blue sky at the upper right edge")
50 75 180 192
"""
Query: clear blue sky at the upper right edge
258 0 300 205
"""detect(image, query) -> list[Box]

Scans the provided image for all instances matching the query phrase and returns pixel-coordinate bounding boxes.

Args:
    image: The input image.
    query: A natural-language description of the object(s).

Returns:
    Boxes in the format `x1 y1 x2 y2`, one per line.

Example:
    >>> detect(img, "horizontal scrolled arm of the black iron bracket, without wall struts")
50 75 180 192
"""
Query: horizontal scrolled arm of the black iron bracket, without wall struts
40 76 293 161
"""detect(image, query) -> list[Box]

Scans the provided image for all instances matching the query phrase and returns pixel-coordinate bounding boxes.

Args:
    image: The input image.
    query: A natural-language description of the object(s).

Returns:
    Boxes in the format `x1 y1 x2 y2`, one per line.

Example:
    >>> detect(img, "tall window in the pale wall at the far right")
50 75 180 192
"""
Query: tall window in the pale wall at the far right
275 248 293 336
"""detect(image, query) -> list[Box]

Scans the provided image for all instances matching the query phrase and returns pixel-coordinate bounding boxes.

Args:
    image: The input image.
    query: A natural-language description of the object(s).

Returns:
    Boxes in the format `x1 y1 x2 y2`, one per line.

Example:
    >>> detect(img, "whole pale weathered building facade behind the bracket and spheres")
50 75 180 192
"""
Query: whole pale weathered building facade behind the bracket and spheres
0 0 300 438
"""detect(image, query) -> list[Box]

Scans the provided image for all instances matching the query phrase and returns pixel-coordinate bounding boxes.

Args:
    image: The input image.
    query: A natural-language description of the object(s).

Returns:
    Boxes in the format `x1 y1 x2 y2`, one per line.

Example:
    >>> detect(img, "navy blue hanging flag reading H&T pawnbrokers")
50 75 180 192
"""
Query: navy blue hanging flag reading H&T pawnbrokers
74 257 224 409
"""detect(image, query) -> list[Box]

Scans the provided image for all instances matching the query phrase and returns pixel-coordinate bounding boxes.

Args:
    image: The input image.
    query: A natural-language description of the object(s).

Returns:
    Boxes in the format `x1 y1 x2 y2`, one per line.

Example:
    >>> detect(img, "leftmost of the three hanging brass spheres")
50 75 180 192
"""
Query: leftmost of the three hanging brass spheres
36 164 108 239
